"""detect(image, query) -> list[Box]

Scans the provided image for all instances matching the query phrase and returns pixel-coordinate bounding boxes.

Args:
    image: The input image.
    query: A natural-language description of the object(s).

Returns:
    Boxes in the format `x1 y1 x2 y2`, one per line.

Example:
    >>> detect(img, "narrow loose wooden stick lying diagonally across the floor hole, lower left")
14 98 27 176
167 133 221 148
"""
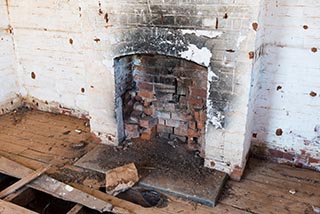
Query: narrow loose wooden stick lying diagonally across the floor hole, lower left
0 165 51 198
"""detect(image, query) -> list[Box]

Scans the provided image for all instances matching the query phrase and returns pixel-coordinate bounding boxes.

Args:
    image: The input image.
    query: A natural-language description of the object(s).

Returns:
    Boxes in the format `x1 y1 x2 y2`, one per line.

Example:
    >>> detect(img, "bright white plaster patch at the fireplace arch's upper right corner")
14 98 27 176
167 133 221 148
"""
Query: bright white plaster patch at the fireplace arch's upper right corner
180 44 212 67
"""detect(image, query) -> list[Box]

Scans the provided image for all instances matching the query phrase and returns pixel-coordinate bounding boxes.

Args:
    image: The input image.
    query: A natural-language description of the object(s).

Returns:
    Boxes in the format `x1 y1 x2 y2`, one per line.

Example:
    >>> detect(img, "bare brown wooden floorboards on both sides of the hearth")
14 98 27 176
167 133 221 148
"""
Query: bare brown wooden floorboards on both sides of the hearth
0 111 320 214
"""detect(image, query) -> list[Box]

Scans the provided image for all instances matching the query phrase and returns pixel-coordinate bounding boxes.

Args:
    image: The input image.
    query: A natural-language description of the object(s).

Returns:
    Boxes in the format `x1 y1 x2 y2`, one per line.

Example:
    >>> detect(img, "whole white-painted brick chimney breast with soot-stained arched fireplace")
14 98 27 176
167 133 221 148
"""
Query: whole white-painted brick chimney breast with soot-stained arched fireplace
82 0 263 179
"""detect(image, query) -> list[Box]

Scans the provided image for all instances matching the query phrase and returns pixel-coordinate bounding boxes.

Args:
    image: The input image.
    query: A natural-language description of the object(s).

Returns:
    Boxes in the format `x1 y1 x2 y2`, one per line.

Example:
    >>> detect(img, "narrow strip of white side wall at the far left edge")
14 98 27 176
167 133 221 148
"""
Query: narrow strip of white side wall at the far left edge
0 0 20 114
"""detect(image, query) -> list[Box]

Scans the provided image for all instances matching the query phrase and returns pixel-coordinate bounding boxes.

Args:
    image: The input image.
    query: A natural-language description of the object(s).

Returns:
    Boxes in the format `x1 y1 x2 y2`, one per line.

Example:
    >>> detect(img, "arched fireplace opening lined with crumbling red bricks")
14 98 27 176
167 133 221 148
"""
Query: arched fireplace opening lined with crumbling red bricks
114 54 208 151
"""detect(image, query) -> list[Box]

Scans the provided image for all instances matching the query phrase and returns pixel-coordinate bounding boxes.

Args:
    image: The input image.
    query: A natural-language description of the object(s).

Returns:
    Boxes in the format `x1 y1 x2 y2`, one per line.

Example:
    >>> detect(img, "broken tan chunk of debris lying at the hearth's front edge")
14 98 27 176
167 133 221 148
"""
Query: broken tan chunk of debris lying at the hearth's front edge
106 163 139 195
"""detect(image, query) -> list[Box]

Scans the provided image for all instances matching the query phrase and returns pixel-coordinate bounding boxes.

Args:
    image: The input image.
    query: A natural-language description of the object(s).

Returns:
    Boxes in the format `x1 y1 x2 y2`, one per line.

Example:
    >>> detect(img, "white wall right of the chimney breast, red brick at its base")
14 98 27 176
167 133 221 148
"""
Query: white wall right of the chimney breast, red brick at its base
252 0 320 170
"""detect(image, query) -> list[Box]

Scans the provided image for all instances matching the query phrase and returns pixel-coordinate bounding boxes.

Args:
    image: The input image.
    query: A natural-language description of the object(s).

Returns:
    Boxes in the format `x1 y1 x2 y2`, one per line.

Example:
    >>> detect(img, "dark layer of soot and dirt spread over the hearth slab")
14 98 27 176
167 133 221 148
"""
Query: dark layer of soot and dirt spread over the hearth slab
96 138 219 184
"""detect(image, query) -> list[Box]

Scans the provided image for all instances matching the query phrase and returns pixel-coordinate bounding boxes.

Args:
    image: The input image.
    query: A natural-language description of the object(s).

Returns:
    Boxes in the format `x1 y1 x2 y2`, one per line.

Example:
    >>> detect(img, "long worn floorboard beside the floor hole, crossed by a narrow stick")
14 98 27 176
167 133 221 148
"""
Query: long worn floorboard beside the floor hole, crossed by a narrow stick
0 157 113 212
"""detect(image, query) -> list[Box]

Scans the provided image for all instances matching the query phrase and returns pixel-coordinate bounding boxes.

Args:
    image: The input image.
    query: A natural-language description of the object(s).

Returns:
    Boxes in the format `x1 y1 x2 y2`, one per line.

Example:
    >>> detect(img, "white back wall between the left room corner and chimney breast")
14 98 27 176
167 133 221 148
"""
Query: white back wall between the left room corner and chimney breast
9 0 88 116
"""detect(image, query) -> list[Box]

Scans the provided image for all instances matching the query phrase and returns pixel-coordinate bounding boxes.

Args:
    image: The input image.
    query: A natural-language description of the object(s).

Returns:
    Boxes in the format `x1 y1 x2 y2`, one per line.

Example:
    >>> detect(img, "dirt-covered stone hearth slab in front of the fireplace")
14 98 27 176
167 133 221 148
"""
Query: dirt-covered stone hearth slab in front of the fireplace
76 138 228 206
